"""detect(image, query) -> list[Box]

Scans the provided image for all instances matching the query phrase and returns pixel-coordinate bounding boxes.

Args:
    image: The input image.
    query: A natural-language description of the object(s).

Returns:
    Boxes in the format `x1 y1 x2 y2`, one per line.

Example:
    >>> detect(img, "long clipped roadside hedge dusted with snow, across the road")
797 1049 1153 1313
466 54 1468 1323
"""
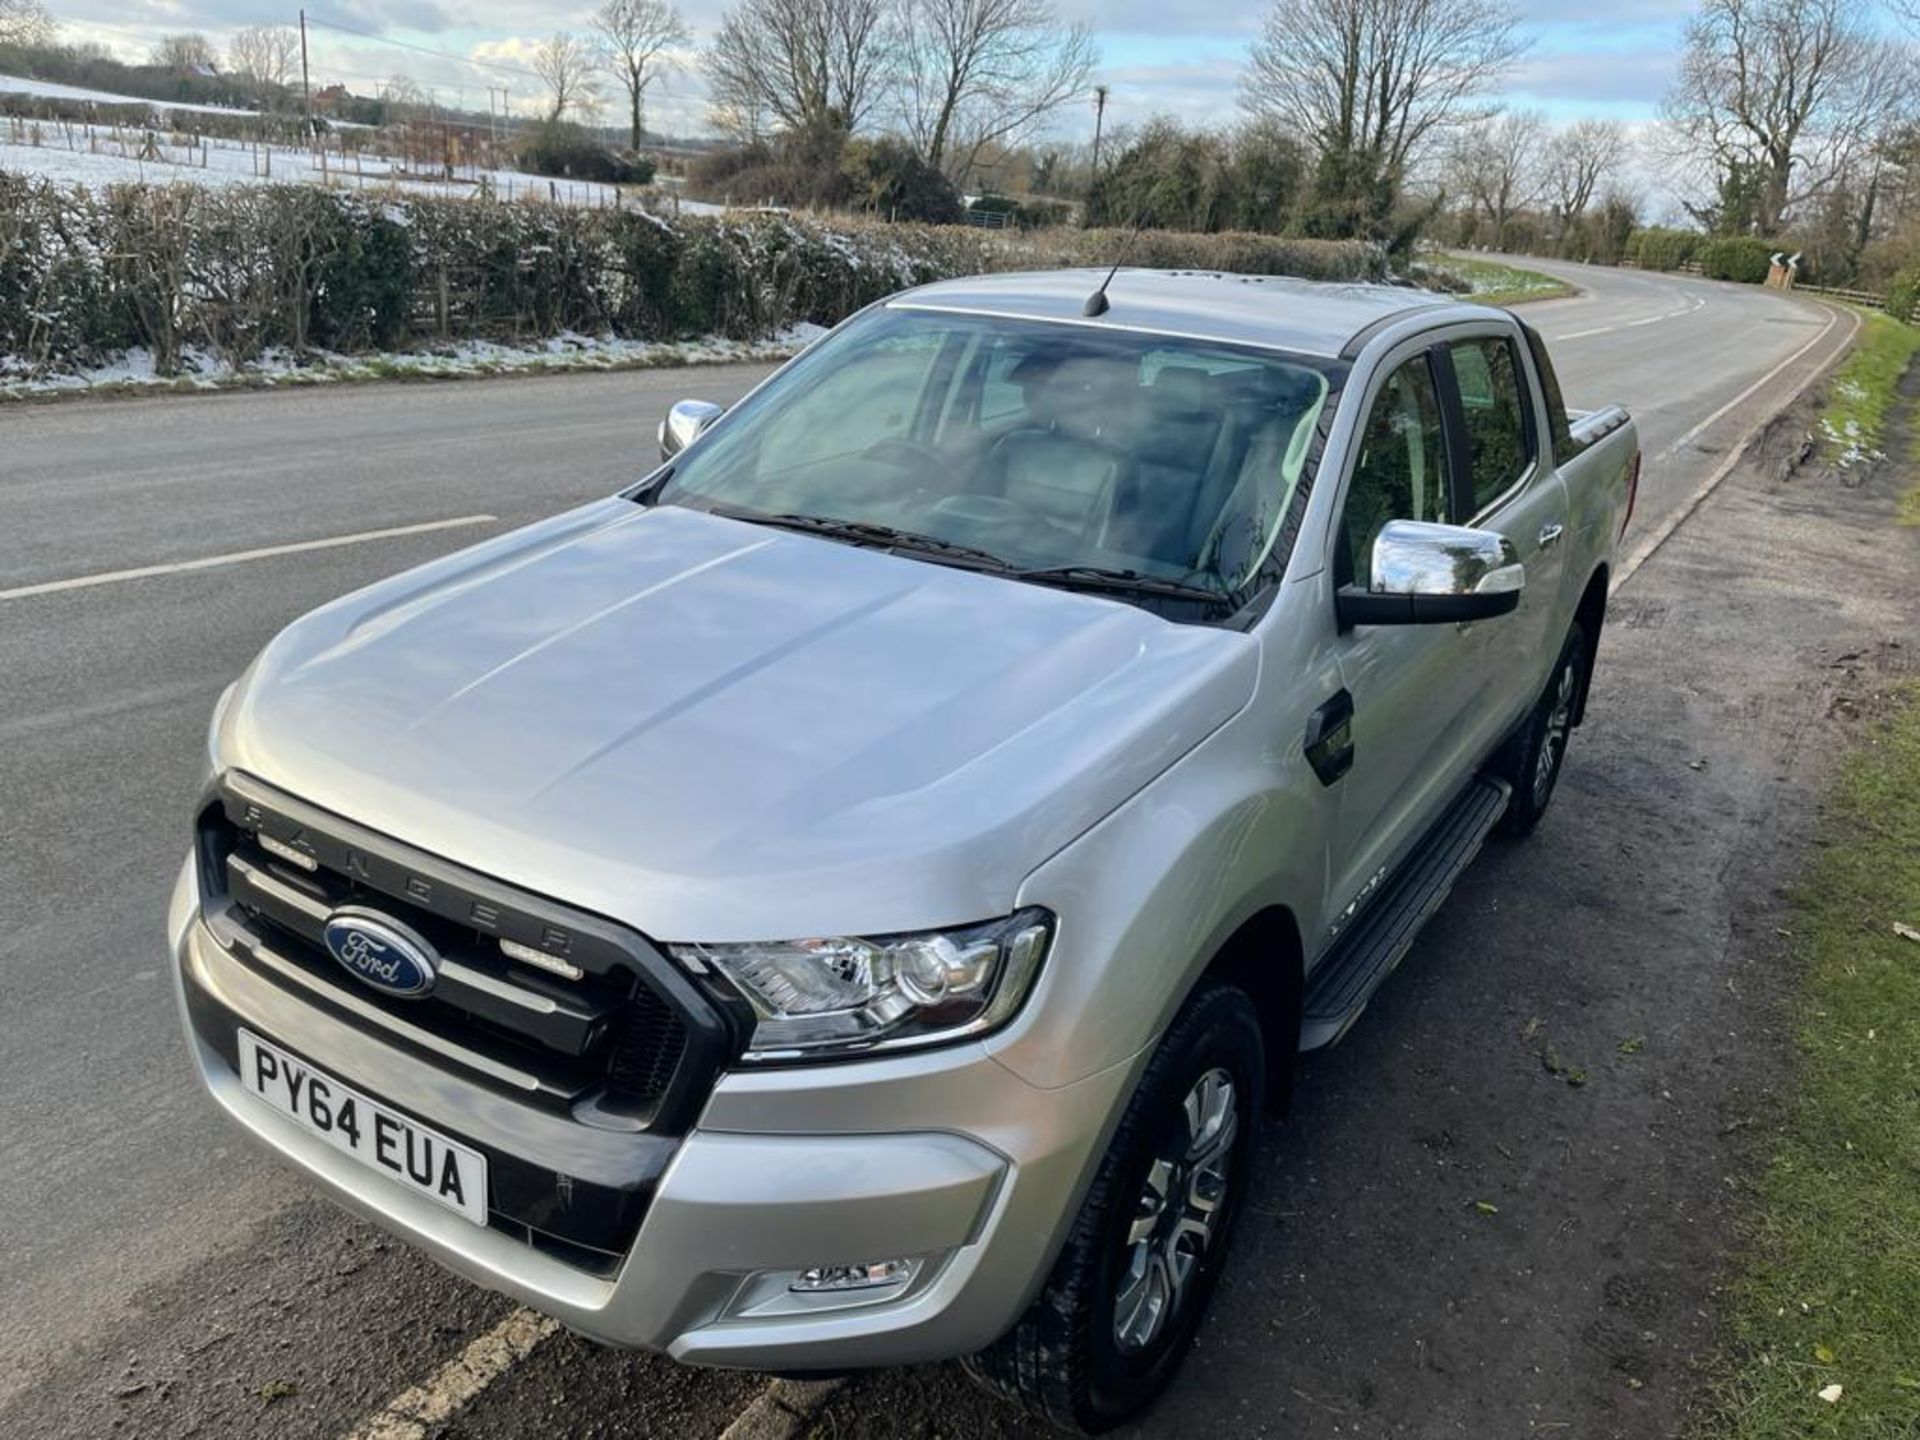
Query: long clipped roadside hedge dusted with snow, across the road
0 171 1386 374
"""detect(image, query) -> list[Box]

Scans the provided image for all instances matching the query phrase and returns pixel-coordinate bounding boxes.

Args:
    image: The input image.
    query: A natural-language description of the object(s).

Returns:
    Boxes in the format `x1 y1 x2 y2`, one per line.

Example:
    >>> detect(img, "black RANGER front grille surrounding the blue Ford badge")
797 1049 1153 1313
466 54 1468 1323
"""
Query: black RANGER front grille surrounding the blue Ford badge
200 774 728 1135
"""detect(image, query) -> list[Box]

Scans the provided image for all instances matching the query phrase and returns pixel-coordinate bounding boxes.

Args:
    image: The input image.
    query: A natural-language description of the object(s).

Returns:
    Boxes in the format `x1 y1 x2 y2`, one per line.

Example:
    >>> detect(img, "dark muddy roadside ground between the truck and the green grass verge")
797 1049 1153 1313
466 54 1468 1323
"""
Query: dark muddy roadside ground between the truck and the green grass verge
783 389 1920 1440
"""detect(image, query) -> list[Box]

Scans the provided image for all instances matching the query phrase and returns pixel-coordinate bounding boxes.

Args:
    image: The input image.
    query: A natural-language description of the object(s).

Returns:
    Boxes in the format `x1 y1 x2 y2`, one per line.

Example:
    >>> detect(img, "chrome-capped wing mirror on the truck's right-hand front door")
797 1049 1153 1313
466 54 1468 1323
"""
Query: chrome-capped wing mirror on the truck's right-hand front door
1334 520 1526 626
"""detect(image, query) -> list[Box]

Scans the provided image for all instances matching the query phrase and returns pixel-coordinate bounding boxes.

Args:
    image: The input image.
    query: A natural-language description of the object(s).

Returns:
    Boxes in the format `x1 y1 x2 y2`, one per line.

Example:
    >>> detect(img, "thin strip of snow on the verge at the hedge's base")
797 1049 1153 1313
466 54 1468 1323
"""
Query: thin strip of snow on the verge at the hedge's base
0 324 826 399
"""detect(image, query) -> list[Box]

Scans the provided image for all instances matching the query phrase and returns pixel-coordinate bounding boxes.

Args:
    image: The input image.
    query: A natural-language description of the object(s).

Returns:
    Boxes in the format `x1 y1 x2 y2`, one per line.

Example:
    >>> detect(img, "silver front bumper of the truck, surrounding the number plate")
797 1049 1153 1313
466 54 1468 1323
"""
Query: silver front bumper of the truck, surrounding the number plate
169 866 1144 1371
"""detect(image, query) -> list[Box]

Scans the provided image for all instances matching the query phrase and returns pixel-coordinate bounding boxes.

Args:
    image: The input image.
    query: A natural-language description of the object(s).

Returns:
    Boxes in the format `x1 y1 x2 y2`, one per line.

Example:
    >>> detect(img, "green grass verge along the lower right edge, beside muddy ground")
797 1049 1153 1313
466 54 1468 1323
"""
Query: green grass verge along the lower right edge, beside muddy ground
1697 685 1920 1440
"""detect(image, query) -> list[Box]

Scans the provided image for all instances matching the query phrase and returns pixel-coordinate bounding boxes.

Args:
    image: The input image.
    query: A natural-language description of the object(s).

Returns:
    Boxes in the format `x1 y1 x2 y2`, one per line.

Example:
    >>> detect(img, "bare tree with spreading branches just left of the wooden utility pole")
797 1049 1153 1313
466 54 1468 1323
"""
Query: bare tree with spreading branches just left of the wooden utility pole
900 0 1096 180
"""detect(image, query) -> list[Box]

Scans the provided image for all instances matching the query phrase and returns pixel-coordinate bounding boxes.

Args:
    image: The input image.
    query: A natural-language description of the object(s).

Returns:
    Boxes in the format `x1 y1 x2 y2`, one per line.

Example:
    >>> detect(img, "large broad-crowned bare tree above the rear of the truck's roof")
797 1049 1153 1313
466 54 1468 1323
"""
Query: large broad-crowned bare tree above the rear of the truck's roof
1240 0 1524 228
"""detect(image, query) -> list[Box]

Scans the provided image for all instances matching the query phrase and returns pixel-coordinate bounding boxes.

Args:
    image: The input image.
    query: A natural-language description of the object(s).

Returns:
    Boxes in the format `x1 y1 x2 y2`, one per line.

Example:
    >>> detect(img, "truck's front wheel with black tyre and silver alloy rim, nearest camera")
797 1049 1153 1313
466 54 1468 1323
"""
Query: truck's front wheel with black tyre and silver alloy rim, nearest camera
966 985 1267 1434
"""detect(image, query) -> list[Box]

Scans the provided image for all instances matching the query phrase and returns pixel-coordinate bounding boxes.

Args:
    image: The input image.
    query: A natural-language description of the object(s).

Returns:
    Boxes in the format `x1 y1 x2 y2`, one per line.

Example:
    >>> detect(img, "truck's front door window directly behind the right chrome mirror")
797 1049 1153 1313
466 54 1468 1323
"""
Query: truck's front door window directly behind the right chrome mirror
1340 355 1452 584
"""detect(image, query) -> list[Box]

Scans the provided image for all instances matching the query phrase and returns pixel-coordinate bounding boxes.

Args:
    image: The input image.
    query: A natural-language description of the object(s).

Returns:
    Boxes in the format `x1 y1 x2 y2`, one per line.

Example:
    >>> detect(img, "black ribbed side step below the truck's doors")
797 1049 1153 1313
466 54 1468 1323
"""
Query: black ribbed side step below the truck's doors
1300 776 1511 1050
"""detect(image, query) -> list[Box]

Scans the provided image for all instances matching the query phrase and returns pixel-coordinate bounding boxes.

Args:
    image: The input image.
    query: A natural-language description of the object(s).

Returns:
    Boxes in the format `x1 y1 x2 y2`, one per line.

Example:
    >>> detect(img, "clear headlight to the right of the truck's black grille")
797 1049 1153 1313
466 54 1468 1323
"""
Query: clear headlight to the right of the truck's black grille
666 910 1054 1060
